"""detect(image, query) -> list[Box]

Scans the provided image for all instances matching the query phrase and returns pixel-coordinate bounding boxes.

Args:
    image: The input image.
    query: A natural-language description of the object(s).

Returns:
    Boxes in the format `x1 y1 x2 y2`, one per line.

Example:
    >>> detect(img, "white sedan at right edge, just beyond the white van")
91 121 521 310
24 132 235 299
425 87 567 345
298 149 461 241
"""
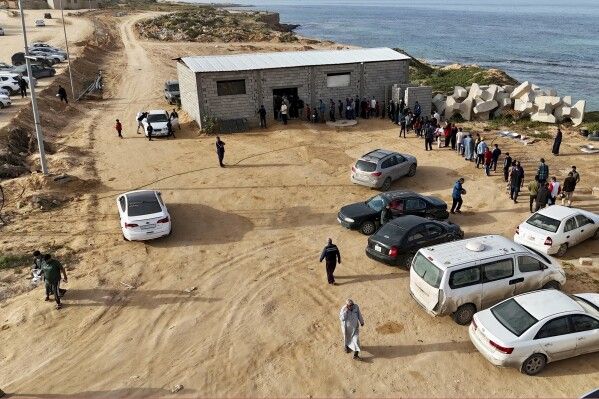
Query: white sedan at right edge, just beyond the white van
514 205 599 256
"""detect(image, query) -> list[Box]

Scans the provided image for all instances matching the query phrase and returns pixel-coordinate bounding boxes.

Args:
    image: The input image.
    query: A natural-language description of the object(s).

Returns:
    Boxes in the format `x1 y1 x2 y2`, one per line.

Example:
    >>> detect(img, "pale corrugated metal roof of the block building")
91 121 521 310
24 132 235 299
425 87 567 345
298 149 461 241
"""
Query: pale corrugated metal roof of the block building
181 47 410 72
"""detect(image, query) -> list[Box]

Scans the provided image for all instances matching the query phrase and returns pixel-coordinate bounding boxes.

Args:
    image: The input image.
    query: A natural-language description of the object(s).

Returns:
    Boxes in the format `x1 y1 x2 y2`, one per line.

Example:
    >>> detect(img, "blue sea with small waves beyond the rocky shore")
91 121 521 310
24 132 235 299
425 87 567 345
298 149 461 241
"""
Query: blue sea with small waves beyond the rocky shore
190 0 599 111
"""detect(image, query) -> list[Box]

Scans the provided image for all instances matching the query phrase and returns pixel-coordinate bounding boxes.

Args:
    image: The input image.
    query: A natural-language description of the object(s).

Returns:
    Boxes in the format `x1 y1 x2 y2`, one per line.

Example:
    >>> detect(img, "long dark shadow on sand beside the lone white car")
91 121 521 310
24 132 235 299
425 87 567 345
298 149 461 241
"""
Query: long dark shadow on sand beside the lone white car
147 203 254 248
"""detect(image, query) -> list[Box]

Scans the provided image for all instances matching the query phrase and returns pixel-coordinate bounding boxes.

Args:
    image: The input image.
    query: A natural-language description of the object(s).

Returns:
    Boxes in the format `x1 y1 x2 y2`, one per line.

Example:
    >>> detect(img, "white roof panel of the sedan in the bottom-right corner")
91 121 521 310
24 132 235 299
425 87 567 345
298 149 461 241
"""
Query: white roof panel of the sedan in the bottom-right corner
514 290 584 320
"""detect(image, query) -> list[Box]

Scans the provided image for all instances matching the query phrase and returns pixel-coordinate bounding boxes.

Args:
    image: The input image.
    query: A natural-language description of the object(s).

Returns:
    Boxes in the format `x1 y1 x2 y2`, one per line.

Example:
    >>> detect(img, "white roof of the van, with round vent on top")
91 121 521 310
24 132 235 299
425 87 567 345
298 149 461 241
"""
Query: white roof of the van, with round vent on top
420 235 530 270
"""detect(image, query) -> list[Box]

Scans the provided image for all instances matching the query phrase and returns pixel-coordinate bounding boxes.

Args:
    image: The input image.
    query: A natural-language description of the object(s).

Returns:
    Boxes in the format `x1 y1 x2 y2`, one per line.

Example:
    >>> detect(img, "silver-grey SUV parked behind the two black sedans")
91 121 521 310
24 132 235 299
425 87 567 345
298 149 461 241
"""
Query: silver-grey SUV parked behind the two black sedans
351 149 418 191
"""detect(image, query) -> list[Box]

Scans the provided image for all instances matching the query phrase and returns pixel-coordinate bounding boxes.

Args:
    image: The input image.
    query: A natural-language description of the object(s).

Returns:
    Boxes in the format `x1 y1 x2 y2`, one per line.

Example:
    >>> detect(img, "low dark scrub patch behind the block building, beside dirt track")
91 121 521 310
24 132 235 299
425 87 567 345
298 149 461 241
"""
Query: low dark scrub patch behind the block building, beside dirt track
136 7 297 42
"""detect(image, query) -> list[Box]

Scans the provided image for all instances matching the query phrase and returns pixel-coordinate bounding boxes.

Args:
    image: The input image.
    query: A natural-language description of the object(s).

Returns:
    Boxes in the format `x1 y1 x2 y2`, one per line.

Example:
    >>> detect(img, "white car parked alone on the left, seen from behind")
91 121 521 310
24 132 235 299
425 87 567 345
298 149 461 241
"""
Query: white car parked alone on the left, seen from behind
116 190 171 241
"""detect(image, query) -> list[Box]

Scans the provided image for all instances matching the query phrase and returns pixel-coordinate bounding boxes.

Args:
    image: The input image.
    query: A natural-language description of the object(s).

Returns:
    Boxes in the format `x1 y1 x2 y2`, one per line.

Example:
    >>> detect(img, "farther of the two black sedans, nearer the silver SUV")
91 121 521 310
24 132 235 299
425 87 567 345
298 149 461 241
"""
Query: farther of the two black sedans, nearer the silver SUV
337 191 449 235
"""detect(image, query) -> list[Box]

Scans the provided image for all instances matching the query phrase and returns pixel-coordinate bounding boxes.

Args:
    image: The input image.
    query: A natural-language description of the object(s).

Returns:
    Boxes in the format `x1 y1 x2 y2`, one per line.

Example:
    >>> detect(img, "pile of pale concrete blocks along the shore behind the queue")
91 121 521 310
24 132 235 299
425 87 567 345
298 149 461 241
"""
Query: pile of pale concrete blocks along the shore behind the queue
433 82 586 126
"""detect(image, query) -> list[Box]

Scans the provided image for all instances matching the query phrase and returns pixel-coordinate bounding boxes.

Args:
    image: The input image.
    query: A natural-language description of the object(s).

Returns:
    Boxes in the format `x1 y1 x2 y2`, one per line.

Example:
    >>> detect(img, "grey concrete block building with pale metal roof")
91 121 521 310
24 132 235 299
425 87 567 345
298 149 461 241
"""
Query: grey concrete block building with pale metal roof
177 48 410 128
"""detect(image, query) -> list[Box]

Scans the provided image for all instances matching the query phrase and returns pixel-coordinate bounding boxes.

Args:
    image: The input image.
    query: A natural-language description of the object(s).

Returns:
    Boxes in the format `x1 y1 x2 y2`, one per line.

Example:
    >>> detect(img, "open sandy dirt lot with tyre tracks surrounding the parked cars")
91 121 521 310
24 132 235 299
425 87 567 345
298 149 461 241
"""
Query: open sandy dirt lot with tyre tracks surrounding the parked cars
0 10 599 398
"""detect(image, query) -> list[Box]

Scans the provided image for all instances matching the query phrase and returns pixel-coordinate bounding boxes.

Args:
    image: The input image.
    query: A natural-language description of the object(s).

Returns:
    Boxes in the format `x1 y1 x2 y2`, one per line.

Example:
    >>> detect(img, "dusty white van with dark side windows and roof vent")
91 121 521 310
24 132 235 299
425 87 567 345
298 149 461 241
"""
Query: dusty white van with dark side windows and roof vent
410 235 566 325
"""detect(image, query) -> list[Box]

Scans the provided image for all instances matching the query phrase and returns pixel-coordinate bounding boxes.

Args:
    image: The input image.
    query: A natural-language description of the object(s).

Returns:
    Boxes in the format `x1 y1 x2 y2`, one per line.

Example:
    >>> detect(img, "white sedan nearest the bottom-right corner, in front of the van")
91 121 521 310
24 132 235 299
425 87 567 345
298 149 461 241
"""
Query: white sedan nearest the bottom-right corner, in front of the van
468 290 599 375
